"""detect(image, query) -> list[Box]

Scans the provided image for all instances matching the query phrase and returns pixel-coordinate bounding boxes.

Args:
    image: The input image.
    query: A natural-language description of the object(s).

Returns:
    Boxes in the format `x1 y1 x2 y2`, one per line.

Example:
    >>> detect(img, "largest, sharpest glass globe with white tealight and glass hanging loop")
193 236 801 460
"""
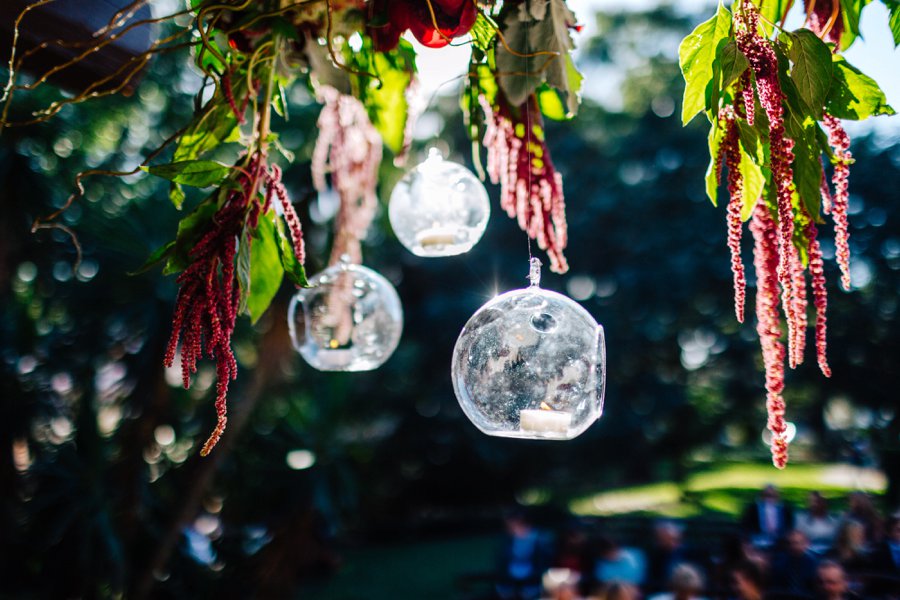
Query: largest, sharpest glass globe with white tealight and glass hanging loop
451 258 606 440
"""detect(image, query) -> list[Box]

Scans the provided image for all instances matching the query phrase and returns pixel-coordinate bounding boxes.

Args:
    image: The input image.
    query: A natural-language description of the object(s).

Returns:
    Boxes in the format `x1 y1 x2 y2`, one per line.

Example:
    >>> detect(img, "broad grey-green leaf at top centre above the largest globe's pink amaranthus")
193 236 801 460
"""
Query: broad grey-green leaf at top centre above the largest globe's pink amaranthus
494 0 582 115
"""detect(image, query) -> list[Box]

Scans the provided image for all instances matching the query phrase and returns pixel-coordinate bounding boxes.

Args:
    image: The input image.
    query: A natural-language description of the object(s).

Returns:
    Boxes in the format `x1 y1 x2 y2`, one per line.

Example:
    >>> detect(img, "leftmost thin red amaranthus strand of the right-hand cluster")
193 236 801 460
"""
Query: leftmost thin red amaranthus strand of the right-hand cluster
719 106 747 323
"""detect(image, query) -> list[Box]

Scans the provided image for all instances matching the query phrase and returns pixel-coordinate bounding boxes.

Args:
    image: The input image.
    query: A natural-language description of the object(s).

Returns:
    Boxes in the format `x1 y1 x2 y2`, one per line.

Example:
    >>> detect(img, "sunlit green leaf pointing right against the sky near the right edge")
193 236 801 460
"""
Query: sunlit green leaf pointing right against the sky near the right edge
825 55 894 121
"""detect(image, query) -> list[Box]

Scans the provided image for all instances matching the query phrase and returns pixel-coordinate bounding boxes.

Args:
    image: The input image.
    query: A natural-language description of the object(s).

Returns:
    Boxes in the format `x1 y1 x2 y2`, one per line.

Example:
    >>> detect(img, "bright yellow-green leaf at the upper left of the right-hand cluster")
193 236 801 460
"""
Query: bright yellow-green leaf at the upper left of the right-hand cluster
678 3 731 125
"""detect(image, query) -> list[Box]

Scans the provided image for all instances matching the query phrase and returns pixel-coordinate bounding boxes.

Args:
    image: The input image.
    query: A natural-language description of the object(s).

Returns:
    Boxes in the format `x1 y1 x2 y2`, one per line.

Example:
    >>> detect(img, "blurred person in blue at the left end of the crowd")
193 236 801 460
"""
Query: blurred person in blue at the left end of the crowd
496 511 552 600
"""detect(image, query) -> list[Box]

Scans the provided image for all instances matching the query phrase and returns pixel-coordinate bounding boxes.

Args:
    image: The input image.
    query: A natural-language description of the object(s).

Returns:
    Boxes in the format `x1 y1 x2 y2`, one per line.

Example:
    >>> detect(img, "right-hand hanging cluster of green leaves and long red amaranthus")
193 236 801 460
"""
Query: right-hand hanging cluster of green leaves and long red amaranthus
679 0 900 468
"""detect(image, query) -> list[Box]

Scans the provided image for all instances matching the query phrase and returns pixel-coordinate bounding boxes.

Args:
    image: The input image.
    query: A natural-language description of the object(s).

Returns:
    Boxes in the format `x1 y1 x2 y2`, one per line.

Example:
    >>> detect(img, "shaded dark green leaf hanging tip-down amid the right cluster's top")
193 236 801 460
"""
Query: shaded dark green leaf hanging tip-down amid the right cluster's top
779 29 831 119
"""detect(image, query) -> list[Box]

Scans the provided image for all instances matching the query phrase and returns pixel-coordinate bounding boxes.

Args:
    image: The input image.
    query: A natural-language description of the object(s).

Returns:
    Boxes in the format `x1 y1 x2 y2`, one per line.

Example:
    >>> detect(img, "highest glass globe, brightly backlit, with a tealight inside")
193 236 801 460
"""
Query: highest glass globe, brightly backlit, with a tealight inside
388 148 491 257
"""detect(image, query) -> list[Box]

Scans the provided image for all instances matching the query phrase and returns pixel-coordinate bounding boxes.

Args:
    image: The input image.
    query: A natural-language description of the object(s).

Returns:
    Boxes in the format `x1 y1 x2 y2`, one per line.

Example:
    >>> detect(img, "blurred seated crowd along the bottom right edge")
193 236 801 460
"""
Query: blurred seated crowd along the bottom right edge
494 486 900 600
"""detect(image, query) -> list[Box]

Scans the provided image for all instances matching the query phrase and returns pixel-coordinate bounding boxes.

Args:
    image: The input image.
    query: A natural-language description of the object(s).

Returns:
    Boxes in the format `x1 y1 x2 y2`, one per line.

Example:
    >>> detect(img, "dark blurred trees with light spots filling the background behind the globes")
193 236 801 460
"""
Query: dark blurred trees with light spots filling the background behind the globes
0 3 900 598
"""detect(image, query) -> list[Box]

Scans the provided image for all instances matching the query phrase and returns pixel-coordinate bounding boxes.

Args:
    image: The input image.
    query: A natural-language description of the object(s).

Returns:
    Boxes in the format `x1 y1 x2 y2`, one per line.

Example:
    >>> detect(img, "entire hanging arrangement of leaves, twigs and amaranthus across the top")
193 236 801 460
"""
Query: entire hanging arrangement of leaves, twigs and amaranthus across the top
0 0 900 467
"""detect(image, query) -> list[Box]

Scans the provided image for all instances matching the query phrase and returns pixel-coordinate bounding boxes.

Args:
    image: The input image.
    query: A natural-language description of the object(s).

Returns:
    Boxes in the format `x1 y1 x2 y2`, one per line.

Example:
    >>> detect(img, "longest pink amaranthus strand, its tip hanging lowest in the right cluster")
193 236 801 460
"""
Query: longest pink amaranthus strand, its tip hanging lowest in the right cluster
750 199 788 469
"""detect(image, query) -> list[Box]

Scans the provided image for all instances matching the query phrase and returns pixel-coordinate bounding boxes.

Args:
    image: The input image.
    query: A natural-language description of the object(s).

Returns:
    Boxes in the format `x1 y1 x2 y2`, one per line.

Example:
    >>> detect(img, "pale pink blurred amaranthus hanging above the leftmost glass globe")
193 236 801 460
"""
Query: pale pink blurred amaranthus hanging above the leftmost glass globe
312 86 382 264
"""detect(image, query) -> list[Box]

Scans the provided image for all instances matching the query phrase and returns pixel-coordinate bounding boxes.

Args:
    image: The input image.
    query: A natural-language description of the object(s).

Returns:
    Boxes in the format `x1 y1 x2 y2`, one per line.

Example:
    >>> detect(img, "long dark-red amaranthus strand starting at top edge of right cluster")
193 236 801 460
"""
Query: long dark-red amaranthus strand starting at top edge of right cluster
735 2 800 366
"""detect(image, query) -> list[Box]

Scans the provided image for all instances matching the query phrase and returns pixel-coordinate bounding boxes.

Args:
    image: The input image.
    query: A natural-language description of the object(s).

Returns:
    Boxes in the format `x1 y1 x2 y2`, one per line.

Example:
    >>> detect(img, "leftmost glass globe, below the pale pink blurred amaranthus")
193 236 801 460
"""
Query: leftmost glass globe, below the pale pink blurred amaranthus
288 261 403 371
